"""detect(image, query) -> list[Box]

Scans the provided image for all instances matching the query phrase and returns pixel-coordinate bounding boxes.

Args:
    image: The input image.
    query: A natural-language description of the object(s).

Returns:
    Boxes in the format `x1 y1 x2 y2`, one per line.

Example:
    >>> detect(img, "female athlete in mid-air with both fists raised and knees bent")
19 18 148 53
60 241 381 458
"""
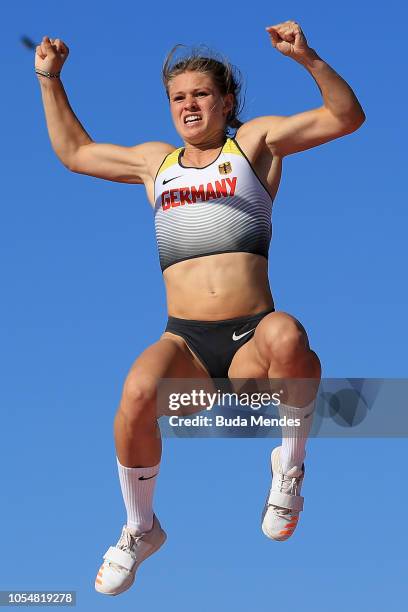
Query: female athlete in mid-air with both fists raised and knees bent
35 21 365 595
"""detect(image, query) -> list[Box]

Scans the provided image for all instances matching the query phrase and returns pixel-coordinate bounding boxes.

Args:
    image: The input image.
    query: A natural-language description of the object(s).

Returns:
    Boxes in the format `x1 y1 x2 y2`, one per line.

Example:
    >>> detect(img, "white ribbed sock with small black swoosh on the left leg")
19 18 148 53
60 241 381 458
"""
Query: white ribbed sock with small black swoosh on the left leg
116 458 160 535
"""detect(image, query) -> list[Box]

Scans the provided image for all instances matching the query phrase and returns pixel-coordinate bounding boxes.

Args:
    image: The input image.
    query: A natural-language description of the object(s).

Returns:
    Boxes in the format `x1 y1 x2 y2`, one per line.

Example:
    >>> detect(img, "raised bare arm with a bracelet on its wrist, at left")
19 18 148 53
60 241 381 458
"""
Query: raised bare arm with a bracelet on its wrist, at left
35 36 173 183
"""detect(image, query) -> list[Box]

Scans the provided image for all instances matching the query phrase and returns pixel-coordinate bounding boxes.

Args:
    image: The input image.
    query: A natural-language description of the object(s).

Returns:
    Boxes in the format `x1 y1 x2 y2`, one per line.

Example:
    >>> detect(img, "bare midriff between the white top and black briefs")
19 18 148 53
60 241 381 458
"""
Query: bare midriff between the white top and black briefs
163 253 273 321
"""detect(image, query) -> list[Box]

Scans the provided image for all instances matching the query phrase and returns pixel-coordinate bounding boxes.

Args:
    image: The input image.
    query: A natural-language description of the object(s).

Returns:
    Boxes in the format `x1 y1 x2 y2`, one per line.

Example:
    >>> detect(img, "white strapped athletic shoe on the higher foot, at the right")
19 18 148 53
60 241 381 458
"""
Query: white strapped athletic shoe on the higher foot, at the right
262 446 305 542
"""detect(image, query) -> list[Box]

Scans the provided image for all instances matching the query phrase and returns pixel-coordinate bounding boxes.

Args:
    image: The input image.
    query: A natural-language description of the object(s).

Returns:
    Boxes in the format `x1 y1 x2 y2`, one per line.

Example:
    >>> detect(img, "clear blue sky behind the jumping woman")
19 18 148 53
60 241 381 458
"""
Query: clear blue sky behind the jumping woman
0 0 408 612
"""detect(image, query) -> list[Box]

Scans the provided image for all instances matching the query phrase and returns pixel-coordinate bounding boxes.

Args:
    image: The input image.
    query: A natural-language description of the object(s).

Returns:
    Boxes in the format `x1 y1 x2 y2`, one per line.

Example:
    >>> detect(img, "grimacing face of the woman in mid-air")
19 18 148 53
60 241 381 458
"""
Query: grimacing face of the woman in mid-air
169 71 233 143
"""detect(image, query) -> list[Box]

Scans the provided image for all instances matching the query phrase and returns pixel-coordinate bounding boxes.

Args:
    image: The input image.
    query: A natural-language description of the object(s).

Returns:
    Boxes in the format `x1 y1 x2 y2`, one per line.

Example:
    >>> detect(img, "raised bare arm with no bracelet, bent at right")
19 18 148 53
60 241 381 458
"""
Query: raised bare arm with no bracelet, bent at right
241 21 365 157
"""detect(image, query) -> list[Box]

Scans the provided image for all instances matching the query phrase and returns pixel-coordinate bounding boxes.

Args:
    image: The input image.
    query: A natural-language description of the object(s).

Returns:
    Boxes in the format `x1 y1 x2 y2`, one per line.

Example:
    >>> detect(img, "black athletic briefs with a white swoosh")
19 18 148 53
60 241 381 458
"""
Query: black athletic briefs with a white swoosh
166 308 274 378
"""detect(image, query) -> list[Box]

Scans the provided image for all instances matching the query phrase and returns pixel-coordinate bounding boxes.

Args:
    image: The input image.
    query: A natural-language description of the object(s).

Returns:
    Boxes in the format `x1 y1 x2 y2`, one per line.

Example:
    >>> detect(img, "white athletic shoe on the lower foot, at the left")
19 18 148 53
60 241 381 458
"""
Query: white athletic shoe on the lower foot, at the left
95 516 166 595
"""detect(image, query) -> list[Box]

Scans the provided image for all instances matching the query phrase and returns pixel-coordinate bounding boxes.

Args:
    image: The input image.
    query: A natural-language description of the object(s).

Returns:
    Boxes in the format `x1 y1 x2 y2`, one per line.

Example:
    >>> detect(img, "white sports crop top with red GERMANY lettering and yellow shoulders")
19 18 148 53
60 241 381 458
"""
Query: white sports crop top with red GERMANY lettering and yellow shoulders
154 138 272 271
